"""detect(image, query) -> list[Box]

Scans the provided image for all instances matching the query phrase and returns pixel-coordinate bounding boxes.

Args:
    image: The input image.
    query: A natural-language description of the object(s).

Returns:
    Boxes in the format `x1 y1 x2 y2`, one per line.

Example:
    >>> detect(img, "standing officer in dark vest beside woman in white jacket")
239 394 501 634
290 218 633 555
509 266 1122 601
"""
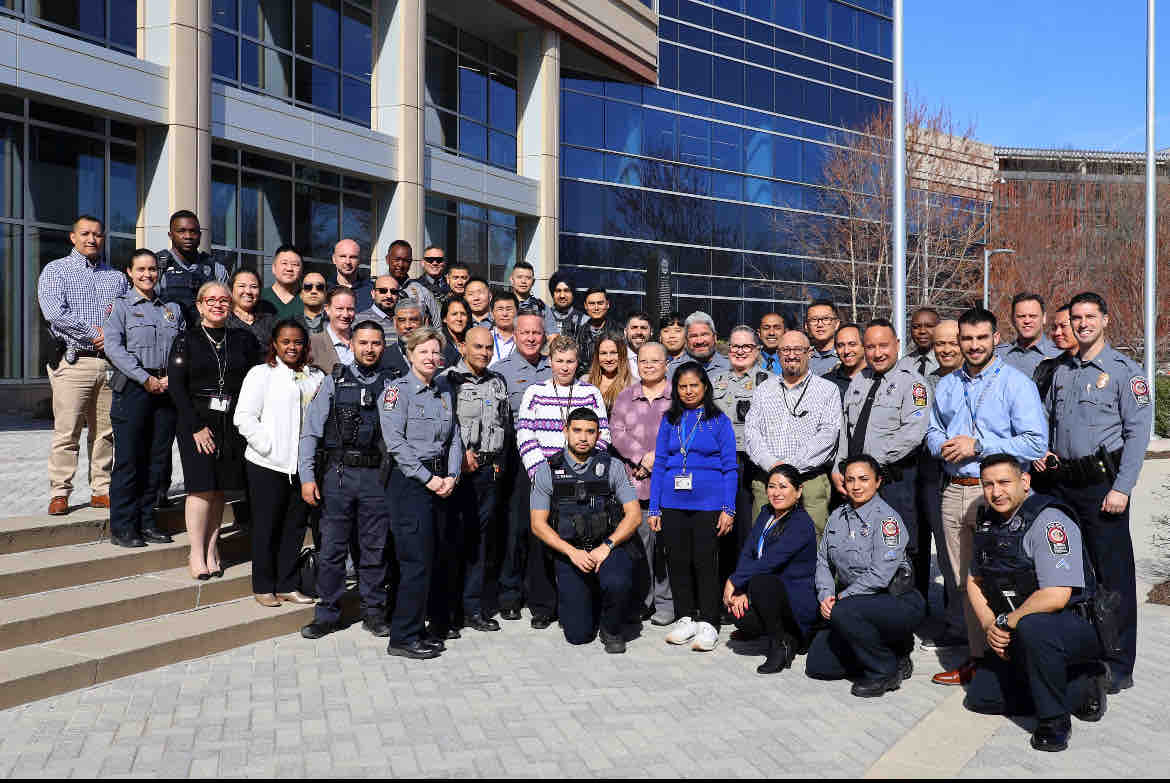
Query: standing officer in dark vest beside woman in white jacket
297 321 394 639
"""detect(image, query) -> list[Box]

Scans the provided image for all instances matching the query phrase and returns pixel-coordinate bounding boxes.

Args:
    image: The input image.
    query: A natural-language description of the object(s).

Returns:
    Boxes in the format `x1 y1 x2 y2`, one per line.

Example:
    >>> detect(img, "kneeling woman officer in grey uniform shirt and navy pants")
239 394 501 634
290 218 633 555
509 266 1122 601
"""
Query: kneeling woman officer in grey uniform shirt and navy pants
805 454 925 696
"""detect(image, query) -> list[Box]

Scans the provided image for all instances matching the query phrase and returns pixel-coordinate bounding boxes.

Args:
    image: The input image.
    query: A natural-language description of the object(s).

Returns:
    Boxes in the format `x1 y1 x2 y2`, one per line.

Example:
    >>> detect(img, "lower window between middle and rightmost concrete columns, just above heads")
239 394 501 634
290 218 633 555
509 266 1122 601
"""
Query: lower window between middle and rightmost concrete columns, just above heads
426 195 517 286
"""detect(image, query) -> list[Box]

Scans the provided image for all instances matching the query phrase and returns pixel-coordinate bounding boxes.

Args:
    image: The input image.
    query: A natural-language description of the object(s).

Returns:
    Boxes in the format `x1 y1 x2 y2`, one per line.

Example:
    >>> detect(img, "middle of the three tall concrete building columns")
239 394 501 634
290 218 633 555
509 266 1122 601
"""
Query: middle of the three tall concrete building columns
370 0 427 273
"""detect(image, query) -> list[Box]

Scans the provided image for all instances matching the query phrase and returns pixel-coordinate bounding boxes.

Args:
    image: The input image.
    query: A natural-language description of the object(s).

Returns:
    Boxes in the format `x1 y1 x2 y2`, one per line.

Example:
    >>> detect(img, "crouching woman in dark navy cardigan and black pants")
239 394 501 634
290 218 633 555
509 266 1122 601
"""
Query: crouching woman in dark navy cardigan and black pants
723 465 817 674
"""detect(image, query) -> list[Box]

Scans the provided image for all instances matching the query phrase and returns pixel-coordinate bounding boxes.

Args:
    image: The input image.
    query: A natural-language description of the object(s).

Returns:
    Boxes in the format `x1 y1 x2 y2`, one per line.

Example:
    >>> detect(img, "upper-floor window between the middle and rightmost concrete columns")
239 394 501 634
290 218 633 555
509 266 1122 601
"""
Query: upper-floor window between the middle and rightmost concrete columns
426 16 516 171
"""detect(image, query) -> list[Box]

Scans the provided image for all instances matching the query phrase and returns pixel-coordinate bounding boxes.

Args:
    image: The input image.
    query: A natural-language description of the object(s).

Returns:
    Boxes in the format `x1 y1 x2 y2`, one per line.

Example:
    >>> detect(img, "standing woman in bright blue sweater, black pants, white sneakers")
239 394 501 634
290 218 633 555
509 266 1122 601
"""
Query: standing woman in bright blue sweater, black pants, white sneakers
646 362 738 652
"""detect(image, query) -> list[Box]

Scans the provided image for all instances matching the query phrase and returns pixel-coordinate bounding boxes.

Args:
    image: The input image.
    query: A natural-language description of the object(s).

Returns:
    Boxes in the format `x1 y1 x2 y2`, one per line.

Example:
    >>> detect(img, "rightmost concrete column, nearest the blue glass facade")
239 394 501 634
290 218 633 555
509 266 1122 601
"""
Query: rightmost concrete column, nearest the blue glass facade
516 29 560 296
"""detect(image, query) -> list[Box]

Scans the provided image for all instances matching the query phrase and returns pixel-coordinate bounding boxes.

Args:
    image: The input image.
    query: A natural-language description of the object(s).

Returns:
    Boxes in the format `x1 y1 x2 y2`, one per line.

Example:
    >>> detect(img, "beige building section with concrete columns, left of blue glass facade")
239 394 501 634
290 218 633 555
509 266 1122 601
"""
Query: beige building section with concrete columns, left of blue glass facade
0 0 659 408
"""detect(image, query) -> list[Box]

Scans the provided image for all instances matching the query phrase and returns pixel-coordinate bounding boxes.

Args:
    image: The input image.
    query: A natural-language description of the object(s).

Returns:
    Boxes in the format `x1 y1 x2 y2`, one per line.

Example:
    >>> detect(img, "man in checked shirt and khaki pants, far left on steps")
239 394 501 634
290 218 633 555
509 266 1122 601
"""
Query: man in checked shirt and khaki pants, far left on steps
36 215 129 515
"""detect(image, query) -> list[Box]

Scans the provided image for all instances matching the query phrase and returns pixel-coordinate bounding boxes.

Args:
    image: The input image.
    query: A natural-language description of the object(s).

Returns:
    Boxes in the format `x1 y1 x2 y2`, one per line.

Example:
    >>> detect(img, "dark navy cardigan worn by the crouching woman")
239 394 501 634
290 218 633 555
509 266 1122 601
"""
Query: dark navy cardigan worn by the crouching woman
728 506 818 634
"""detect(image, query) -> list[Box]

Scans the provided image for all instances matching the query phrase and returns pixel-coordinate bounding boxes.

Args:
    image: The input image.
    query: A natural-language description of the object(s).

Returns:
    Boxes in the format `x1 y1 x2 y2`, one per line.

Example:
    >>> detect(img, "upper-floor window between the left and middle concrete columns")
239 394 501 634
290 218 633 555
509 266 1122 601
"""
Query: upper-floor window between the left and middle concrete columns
212 0 373 128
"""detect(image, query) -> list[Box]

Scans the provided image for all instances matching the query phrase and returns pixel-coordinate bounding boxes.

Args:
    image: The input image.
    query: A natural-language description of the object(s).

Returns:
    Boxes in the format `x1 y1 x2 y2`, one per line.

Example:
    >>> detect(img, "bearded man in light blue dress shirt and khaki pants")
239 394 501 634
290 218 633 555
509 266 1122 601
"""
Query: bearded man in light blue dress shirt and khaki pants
927 308 1048 685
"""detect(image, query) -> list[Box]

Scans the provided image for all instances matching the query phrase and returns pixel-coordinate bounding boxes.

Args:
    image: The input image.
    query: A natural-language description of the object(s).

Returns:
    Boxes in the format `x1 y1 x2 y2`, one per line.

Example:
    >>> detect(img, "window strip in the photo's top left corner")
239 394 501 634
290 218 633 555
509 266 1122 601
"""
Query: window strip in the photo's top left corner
0 0 138 54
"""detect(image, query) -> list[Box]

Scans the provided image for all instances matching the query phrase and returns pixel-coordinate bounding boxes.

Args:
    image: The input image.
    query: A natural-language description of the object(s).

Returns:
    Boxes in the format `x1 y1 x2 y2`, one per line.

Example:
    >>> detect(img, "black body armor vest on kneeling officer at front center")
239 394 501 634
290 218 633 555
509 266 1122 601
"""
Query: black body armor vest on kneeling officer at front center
549 453 622 550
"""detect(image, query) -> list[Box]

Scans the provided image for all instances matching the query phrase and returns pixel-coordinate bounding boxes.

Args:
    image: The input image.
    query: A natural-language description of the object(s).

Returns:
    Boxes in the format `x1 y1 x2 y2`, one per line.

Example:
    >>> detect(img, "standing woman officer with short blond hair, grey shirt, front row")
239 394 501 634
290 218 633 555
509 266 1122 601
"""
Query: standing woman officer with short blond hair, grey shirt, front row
380 327 463 659
